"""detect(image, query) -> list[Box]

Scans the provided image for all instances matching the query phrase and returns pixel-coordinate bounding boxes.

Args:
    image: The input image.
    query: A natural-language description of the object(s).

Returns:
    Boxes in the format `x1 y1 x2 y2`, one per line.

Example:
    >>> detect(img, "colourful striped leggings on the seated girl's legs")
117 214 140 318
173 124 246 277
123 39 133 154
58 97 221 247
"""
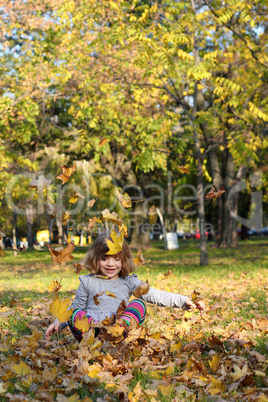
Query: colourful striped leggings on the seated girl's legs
68 299 146 342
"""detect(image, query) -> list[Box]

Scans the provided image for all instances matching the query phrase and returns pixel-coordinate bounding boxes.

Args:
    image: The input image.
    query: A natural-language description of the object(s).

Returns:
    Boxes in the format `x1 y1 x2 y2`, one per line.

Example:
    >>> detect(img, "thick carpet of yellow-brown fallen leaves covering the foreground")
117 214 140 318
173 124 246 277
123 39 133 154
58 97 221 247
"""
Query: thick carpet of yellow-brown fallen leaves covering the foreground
0 271 268 402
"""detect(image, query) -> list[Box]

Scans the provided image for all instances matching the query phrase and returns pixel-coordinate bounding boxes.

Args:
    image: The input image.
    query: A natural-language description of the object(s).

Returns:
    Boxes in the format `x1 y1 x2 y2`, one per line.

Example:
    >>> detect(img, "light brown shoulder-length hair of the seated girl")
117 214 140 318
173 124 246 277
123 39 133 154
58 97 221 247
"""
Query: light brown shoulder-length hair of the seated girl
83 232 136 277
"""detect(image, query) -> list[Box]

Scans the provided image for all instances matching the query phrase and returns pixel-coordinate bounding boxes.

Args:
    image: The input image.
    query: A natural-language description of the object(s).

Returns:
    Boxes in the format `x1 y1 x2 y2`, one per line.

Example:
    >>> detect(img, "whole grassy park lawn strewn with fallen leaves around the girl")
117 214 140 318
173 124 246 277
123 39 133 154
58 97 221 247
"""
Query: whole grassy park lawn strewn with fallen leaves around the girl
0 238 268 401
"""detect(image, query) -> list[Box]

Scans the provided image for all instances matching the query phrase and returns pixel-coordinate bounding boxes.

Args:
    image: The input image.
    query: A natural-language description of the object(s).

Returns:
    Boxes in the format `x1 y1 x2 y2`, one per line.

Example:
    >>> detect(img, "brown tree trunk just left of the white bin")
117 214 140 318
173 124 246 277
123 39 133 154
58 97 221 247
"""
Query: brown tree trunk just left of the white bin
130 203 150 249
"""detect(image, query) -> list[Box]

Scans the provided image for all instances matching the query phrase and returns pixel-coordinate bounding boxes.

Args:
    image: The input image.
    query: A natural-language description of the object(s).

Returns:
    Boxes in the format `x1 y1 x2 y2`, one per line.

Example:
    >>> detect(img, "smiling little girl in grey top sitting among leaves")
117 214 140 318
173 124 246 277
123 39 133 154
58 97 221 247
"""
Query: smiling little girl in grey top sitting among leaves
45 232 205 342
